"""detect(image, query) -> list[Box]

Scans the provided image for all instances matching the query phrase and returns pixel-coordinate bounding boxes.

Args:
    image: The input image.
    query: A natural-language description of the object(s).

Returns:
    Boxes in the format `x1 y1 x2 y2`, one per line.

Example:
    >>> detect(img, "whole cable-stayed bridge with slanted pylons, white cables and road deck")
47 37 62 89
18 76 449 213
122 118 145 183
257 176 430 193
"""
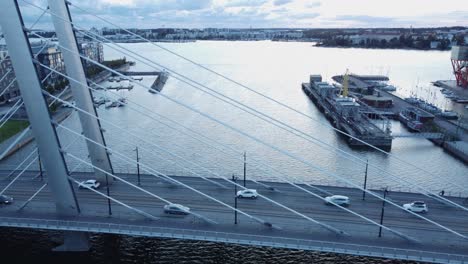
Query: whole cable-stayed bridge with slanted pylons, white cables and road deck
0 0 468 263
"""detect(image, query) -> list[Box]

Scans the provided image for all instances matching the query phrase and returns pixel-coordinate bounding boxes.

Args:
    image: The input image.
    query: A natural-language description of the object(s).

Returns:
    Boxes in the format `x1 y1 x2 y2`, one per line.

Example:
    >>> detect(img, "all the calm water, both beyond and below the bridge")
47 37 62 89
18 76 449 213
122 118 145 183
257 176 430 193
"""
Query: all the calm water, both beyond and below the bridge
0 41 462 263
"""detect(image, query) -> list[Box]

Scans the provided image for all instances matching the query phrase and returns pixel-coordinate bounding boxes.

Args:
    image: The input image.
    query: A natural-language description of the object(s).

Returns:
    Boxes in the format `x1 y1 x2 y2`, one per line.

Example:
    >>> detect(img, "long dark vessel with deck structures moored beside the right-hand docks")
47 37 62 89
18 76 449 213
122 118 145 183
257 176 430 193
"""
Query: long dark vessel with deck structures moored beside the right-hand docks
302 75 393 150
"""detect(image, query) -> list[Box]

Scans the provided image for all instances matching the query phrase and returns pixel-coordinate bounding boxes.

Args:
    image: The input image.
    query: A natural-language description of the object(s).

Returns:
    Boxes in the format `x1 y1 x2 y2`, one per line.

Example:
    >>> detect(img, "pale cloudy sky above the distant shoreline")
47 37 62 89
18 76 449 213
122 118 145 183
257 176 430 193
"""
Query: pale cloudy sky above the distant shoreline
19 0 468 28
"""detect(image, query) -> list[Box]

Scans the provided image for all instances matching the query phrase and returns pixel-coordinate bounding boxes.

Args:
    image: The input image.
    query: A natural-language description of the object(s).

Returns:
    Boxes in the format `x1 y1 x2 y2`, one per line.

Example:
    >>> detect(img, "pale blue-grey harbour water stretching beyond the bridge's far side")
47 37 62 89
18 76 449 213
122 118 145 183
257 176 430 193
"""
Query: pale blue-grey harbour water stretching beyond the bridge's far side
2 41 468 195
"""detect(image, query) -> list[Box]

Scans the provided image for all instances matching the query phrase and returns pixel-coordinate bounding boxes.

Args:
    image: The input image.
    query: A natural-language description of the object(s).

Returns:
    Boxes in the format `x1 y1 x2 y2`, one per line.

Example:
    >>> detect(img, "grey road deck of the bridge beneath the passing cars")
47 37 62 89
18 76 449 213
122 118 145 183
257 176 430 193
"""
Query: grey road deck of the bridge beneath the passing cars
0 172 468 263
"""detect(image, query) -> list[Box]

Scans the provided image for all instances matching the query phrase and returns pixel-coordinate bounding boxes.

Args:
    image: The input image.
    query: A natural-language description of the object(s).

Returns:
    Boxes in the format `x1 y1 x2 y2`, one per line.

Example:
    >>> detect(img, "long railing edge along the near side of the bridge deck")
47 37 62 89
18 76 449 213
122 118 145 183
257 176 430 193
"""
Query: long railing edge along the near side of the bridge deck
0 217 468 263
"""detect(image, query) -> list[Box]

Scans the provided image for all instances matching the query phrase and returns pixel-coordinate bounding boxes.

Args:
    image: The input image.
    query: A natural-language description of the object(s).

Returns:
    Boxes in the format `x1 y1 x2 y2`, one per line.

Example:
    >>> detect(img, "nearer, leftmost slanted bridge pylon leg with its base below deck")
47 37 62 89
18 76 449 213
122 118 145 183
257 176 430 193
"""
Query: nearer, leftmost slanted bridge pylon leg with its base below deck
0 0 89 251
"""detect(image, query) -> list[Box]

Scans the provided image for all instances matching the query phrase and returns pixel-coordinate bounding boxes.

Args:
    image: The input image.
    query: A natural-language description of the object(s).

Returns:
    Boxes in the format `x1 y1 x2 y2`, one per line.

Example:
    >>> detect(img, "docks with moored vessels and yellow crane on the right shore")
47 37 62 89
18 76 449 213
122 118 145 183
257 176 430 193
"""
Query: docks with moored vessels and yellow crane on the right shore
302 69 468 163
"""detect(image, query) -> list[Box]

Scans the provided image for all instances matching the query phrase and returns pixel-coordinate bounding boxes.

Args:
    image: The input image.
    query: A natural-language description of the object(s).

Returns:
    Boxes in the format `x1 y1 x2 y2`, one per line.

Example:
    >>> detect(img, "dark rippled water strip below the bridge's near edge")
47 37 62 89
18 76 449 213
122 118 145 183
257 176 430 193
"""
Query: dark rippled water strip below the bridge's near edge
0 228 416 264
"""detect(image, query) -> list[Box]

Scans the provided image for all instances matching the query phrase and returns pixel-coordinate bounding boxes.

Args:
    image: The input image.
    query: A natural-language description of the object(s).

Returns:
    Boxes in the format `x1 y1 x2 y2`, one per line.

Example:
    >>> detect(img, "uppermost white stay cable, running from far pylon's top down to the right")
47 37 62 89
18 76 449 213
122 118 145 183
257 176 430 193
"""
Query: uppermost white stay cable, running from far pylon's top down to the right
59 0 468 198
